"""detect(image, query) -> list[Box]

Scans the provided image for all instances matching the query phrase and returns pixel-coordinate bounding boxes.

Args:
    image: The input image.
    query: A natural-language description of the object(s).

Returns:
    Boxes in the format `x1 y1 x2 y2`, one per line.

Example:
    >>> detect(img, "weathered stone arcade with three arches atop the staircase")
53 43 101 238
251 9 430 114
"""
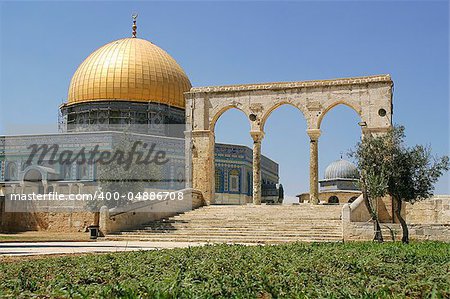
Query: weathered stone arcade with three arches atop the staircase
186 75 393 204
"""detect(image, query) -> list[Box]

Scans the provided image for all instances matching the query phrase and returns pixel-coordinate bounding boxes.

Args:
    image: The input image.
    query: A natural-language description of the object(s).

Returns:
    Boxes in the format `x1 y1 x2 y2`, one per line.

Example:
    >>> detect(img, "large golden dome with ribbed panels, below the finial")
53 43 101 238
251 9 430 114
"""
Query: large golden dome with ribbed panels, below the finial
68 38 191 109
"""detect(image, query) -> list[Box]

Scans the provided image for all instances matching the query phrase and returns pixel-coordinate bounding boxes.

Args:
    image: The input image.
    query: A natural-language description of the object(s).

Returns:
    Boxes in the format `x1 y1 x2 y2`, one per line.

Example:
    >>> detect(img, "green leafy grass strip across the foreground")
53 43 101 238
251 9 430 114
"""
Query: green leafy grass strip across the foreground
0 242 450 298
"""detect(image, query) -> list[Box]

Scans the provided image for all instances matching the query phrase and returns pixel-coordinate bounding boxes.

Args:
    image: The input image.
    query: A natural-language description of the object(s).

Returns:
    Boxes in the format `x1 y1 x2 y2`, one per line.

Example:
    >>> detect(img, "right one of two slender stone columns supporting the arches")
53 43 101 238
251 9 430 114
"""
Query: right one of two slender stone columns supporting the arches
307 129 320 204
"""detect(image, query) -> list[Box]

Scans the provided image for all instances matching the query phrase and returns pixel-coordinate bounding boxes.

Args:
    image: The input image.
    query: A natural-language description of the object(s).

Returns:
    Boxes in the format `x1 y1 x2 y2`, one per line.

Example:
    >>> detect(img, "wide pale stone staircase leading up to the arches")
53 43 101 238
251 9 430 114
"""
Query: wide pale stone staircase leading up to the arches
106 203 342 244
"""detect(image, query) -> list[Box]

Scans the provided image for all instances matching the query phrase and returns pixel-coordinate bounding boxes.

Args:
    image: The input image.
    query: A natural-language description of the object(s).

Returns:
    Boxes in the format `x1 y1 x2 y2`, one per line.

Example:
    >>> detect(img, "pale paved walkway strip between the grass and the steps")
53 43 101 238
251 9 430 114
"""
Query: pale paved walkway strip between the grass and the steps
0 241 205 256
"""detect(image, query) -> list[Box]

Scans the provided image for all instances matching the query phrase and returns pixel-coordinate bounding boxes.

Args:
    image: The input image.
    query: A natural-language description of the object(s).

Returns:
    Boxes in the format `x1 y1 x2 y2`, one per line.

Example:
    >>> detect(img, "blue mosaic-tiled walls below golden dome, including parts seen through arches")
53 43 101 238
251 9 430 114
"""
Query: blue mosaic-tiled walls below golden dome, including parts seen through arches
0 132 279 204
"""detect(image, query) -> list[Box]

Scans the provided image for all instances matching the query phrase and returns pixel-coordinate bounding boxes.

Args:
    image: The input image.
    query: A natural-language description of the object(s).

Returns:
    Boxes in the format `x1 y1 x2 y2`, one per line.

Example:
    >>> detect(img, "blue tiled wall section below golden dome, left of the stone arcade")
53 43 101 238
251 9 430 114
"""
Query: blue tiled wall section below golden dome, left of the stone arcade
0 132 186 194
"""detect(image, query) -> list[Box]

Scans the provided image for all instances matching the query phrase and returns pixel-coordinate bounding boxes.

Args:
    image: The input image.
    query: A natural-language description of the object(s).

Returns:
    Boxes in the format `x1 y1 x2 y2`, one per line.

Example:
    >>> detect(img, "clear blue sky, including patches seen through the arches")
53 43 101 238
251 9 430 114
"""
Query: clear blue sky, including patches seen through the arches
0 1 450 195
